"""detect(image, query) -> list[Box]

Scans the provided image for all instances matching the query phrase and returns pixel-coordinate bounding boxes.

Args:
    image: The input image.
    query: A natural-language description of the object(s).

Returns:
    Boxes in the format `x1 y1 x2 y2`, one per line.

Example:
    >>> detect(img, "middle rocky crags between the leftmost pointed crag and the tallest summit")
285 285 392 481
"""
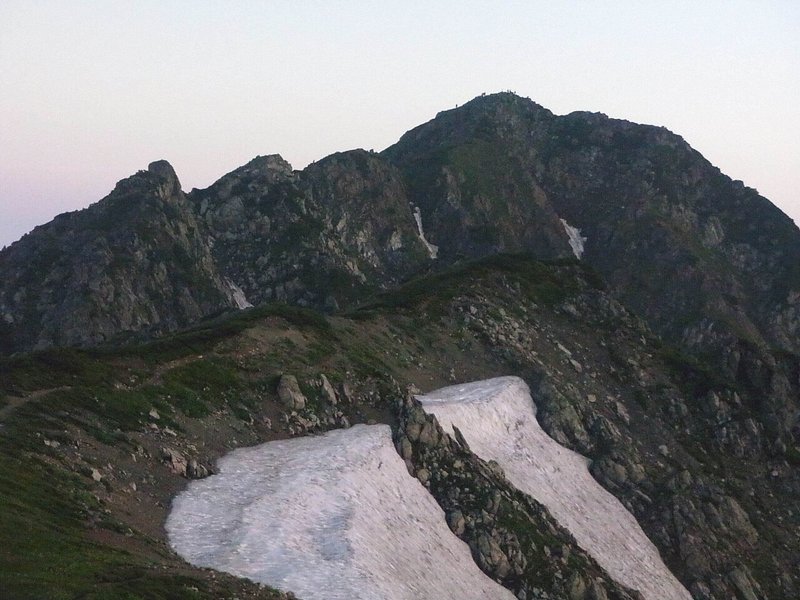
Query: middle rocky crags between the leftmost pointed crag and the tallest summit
190 150 430 310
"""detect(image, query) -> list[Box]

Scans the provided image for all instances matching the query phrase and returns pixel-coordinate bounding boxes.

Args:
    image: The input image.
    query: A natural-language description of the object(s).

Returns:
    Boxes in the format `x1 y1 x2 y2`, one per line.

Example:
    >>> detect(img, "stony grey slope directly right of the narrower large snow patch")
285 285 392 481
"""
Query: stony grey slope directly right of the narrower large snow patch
449 267 800 599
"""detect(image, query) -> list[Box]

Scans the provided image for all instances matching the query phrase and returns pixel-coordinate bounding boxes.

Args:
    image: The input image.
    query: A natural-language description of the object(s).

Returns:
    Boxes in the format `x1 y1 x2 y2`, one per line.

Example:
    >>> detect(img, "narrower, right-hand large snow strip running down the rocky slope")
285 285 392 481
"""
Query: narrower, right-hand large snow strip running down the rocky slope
419 377 691 600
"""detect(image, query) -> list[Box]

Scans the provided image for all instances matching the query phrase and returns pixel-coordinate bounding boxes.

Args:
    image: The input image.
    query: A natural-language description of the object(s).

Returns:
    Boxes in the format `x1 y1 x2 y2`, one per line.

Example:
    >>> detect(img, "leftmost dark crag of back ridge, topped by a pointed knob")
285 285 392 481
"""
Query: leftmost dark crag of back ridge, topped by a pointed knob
0 161 233 350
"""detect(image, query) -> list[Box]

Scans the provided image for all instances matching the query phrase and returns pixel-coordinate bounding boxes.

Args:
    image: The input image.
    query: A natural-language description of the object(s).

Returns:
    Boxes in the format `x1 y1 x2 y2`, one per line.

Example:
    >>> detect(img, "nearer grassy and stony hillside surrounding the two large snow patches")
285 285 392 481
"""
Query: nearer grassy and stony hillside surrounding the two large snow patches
0 257 800 598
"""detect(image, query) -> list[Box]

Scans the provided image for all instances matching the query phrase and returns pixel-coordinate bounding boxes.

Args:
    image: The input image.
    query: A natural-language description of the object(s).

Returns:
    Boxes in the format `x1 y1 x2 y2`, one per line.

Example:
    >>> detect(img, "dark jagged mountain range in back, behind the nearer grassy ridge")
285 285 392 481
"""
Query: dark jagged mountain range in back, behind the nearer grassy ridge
0 93 800 364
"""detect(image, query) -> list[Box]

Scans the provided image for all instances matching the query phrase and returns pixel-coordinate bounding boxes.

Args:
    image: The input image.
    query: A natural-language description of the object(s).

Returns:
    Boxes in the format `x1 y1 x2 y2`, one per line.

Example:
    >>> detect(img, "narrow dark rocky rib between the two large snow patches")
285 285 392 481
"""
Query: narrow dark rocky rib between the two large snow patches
394 394 640 600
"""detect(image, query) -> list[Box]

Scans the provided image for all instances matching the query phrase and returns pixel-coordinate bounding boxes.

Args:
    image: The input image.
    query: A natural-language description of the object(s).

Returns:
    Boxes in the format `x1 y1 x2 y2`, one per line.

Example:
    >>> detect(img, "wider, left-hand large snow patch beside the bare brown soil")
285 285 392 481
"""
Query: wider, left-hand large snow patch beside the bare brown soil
166 425 513 600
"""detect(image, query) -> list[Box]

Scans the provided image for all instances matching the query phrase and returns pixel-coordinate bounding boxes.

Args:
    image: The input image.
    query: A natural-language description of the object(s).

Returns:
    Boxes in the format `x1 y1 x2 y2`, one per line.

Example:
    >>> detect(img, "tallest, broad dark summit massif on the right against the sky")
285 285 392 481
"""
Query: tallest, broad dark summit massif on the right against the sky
383 93 800 353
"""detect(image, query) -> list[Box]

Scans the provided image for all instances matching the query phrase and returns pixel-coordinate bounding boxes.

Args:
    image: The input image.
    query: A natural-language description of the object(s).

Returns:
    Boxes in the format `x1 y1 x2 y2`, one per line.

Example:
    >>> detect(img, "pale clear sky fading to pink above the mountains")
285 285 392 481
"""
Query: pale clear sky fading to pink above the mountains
0 0 800 247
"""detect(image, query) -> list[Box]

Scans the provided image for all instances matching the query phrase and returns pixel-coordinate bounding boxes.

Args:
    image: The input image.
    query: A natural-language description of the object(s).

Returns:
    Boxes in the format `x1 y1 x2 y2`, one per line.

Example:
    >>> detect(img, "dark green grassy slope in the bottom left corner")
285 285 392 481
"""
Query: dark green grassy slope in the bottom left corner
0 436 264 600
